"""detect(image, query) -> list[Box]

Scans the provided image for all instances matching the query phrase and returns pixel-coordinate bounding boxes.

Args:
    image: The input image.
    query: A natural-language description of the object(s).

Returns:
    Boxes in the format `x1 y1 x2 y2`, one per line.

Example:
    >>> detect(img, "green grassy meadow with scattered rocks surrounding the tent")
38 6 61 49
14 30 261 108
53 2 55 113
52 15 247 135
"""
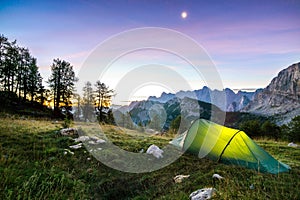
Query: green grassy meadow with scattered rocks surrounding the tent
0 116 300 199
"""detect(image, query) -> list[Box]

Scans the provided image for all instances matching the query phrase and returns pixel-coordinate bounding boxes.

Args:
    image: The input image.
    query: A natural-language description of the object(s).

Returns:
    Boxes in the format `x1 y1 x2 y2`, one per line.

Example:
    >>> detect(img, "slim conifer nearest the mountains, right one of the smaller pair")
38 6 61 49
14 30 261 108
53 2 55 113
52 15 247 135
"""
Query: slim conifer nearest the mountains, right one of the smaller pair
95 81 114 122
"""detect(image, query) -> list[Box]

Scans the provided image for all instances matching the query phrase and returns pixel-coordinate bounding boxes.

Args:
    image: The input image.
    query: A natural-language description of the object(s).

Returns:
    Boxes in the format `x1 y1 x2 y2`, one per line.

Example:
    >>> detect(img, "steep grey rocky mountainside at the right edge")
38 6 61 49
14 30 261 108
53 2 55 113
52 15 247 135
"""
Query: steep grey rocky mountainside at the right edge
242 63 300 124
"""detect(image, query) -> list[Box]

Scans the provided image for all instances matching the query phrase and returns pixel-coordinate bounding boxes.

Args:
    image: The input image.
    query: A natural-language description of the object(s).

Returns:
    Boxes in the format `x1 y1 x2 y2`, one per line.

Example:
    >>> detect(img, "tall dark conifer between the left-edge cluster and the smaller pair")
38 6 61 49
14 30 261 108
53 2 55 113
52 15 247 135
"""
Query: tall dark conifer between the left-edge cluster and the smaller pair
48 59 78 115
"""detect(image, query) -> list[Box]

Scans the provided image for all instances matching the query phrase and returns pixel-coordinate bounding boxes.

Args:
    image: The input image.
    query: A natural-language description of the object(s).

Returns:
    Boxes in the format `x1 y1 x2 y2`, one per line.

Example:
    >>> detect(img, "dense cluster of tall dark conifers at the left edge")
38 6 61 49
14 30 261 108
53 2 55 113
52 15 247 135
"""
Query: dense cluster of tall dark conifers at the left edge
0 35 42 101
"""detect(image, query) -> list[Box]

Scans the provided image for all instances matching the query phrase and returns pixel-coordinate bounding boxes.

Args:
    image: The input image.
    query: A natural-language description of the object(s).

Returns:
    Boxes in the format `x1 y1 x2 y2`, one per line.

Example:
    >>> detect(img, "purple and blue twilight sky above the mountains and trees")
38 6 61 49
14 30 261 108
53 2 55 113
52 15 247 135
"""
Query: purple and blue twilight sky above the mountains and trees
0 0 300 102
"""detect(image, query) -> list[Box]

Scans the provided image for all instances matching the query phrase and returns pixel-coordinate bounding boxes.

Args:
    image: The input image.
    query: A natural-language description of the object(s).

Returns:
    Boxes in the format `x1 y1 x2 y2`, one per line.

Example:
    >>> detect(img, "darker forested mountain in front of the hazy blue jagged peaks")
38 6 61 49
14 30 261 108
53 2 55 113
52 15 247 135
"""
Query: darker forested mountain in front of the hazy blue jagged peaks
113 97 224 130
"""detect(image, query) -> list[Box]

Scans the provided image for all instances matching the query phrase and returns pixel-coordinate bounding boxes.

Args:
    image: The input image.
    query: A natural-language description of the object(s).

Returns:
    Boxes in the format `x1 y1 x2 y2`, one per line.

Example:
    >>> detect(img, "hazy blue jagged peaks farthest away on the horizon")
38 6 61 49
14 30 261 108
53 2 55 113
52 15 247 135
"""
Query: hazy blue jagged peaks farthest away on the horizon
148 86 259 112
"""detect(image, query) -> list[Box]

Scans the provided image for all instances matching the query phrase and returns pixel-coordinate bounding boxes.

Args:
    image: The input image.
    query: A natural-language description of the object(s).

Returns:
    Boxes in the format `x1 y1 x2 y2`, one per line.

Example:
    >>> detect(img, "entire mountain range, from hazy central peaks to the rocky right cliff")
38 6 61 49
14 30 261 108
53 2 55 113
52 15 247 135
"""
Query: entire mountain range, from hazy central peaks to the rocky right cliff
114 63 300 128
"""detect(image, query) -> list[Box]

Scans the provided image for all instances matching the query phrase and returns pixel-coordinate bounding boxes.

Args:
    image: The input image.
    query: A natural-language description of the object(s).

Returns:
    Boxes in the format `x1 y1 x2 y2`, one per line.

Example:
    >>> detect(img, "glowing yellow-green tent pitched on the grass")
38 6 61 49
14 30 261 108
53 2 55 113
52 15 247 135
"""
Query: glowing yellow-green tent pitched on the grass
170 119 290 174
